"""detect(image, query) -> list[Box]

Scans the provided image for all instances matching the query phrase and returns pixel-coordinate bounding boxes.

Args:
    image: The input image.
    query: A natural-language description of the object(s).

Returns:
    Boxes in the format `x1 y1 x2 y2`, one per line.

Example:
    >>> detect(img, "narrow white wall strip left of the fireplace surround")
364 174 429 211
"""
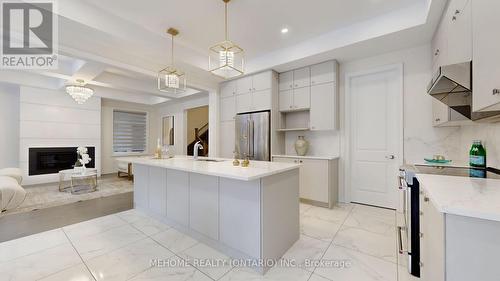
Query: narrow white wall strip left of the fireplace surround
0 84 19 166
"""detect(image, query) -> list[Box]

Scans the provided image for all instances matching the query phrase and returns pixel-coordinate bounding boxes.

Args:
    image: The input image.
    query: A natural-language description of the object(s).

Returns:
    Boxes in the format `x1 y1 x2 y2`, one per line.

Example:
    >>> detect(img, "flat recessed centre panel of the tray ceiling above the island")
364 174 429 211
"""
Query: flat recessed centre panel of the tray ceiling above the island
84 0 423 60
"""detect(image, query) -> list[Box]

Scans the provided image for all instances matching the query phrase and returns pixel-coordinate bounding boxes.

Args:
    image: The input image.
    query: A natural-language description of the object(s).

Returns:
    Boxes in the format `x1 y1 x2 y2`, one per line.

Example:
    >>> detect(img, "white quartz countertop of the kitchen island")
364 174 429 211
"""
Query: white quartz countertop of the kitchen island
116 156 300 181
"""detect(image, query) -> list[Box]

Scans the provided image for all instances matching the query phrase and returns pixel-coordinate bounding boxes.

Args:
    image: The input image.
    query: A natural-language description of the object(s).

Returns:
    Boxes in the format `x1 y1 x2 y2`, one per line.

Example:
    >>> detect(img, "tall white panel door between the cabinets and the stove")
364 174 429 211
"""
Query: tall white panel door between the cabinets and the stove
346 66 403 209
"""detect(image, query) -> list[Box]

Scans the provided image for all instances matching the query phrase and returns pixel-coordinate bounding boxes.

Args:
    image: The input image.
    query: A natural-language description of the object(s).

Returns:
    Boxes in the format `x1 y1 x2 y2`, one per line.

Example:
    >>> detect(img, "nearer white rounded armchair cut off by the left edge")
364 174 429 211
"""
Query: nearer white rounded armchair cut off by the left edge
0 176 26 212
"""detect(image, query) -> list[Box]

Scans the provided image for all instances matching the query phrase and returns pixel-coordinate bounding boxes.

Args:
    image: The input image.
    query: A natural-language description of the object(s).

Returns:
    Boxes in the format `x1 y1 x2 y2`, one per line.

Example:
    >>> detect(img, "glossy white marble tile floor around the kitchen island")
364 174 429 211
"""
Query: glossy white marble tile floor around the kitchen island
0 204 398 281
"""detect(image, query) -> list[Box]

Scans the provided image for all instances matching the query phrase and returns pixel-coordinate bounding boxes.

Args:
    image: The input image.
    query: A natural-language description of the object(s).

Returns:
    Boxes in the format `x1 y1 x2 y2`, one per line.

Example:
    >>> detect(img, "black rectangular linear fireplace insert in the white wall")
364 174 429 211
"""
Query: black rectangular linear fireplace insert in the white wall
28 147 95 176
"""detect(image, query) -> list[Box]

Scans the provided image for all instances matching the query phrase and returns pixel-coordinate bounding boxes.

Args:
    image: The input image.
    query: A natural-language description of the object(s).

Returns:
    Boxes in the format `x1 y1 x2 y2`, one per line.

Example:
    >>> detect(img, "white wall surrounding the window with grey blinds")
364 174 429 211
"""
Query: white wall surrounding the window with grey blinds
101 99 160 174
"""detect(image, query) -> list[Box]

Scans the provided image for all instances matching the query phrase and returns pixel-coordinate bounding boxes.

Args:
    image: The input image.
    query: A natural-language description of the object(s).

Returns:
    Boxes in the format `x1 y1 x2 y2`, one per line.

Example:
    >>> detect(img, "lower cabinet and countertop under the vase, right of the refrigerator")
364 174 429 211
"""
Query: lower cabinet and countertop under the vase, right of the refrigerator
273 156 338 208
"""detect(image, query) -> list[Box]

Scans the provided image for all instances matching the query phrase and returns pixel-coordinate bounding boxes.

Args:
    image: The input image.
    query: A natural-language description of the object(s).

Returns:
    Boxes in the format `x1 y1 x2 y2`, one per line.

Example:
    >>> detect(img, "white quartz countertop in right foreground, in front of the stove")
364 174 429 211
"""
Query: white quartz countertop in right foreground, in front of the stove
417 174 500 221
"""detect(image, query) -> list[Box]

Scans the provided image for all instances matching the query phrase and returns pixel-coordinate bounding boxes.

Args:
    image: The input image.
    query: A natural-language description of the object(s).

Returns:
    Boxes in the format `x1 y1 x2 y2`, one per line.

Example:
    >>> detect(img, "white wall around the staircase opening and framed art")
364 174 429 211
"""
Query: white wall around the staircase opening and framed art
156 94 210 155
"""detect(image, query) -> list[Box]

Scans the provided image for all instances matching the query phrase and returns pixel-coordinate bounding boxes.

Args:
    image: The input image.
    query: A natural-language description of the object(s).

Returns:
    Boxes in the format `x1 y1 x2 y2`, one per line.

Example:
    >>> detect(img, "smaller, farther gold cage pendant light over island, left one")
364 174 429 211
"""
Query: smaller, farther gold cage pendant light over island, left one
157 28 186 94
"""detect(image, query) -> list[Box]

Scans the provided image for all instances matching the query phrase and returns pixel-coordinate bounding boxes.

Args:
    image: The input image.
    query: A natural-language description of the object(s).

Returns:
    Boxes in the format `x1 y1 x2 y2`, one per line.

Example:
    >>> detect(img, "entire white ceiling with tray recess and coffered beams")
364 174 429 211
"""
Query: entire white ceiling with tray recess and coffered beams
0 0 446 104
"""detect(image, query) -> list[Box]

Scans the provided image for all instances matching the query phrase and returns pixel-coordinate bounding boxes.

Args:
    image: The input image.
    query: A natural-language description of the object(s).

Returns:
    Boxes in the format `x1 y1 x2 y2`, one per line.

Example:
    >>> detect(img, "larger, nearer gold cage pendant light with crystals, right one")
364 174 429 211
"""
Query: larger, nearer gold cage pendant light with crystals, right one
208 0 244 79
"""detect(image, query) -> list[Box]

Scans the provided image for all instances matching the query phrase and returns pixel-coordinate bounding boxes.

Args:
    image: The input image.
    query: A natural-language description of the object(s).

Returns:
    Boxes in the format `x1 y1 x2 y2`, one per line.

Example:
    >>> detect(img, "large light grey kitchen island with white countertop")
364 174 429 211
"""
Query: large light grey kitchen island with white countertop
119 156 300 272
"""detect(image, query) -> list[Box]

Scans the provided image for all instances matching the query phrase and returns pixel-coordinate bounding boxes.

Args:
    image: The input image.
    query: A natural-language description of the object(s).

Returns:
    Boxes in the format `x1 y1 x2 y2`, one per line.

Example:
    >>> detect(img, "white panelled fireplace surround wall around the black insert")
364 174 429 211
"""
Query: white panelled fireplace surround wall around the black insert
19 86 101 184
